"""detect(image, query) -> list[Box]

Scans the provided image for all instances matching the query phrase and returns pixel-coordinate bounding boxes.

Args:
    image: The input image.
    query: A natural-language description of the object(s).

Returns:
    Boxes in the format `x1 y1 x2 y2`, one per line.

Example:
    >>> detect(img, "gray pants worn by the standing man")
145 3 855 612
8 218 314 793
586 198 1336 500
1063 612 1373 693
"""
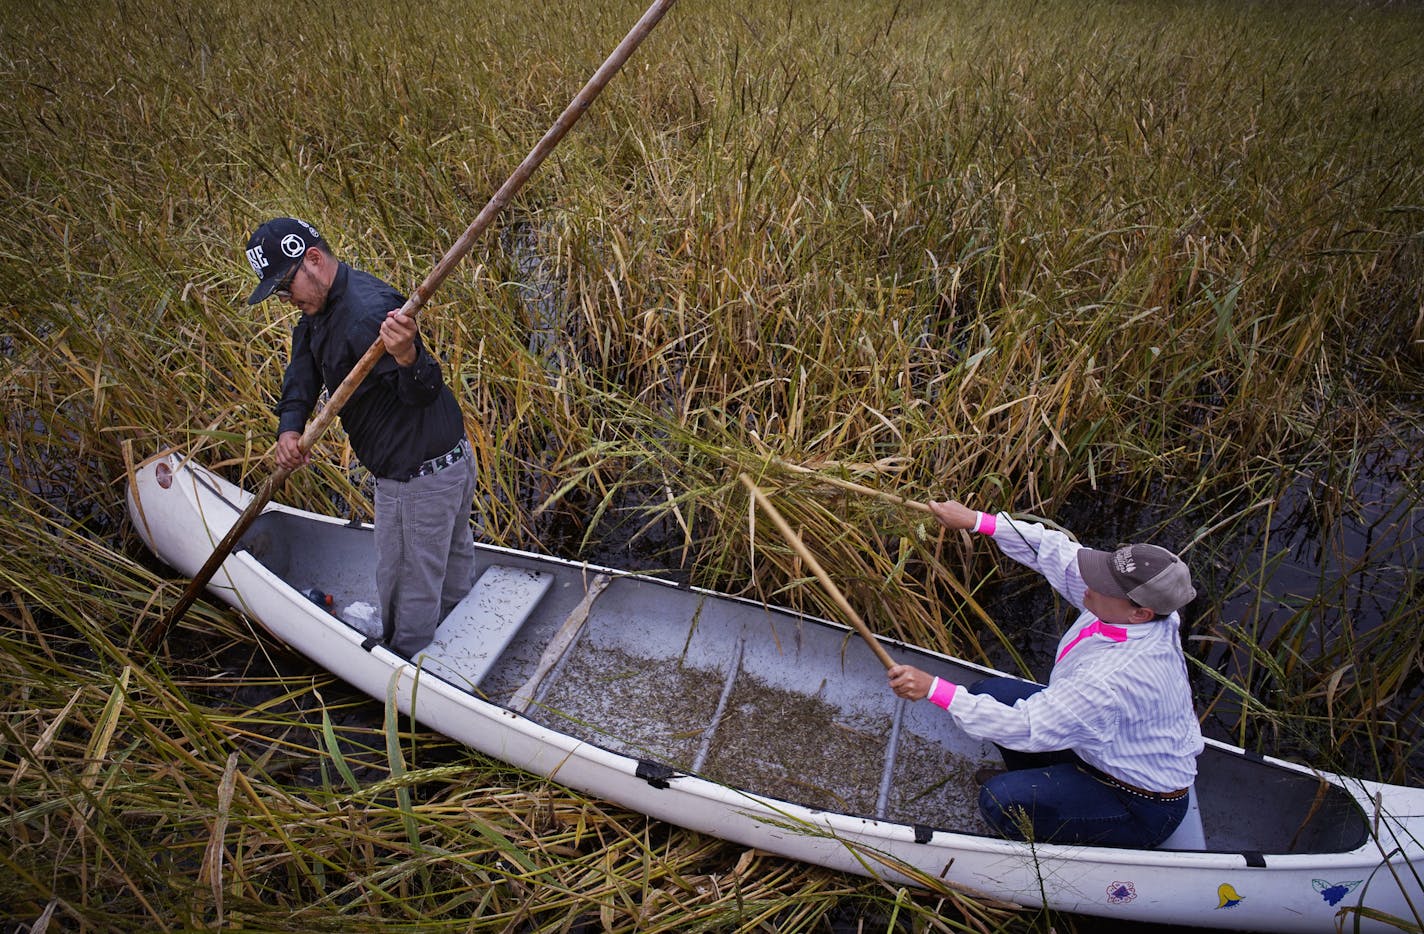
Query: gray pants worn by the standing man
376 457 476 658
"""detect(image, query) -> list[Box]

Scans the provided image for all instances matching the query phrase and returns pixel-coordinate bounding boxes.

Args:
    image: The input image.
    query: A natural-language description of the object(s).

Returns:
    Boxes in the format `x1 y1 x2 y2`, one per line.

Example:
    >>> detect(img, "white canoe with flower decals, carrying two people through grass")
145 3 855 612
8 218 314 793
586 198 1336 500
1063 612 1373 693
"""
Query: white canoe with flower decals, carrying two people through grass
128 454 1424 933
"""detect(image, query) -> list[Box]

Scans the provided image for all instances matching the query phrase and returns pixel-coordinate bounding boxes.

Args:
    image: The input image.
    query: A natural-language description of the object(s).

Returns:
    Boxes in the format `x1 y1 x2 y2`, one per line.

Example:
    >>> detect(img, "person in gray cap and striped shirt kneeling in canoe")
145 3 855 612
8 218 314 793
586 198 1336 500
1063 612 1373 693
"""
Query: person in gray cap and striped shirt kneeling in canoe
889 500 1203 847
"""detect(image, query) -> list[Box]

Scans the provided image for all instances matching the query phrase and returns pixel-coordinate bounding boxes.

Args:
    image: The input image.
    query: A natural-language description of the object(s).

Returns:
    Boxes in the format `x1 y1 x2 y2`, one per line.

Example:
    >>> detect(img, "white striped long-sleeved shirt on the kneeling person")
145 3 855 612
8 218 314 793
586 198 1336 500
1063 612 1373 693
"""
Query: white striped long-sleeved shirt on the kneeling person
947 513 1203 792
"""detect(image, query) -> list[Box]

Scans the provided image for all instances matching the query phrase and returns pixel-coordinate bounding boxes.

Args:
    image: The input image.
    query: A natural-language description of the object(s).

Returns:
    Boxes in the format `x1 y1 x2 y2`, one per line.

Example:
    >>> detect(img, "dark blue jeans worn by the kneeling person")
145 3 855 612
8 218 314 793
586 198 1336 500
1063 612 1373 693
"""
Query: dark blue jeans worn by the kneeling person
968 678 1188 847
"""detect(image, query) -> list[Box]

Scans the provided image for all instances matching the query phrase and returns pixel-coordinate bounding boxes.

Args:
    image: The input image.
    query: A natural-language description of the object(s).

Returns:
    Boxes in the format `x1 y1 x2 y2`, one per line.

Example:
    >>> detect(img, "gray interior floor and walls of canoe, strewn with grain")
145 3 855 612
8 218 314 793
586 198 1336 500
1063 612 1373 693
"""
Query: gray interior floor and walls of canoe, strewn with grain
239 513 1368 854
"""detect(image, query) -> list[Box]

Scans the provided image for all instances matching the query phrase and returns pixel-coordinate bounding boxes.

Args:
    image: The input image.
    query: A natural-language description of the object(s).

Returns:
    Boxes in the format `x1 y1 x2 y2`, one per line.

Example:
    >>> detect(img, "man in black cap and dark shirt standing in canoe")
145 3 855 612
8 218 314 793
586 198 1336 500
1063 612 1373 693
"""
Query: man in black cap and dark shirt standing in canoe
246 218 476 658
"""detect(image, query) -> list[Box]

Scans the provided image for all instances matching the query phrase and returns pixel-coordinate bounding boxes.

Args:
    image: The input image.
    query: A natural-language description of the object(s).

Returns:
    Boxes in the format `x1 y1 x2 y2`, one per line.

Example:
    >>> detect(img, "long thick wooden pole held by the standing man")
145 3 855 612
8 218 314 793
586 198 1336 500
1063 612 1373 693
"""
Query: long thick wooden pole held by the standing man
145 0 675 649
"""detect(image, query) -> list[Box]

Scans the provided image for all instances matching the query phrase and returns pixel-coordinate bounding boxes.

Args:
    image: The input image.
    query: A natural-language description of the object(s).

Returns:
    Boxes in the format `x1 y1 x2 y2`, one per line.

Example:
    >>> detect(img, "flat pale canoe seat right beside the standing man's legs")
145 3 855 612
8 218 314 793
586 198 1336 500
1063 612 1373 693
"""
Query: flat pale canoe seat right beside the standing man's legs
419 564 554 688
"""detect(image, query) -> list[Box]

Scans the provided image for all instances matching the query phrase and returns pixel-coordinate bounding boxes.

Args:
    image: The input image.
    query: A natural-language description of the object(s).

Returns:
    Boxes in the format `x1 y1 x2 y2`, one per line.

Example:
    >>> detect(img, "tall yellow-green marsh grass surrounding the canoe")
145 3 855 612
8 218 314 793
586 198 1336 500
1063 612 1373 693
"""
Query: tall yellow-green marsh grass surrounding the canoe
0 0 1424 931
